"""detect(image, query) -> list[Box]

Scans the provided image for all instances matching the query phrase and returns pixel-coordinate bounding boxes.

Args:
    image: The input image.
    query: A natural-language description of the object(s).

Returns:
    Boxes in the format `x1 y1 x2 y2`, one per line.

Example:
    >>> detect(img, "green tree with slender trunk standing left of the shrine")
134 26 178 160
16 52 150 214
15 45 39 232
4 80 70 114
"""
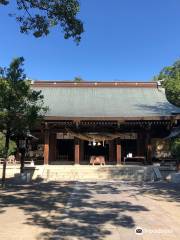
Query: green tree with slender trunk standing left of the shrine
0 57 47 186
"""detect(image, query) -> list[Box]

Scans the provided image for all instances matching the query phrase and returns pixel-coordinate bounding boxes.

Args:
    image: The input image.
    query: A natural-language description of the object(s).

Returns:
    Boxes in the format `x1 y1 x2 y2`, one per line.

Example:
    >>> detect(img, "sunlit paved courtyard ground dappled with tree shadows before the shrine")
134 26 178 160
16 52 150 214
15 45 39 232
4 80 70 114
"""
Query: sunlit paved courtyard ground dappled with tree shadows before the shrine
0 182 180 240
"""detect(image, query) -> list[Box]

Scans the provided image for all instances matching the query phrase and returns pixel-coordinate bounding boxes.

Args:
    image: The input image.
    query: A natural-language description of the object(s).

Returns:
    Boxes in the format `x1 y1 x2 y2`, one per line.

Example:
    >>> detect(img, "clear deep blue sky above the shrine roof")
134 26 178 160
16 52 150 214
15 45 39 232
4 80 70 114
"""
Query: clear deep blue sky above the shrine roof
0 0 180 81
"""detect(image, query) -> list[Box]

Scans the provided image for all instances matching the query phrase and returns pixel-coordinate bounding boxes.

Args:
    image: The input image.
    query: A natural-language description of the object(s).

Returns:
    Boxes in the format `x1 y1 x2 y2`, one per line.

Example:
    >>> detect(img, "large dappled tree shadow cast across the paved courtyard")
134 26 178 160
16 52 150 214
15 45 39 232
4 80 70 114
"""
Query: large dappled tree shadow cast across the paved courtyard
0 182 148 240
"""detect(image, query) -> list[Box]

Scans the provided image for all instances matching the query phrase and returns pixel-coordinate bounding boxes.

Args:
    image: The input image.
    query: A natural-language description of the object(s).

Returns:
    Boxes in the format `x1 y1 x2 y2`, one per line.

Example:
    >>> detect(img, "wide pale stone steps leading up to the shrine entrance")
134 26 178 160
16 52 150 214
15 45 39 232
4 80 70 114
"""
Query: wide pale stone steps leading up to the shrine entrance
41 165 158 181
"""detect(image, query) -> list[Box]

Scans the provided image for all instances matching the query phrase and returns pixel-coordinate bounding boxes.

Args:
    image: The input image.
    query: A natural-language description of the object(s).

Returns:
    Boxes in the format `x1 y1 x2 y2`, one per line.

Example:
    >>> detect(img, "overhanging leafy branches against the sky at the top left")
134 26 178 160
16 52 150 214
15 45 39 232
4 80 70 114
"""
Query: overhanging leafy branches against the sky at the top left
0 0 84 43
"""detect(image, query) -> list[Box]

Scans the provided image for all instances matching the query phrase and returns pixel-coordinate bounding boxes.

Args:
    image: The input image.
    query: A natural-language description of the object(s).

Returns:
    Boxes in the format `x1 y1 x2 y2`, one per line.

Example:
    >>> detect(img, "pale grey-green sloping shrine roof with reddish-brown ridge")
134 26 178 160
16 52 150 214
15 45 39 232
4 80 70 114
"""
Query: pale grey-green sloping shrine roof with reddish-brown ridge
32 82 180 118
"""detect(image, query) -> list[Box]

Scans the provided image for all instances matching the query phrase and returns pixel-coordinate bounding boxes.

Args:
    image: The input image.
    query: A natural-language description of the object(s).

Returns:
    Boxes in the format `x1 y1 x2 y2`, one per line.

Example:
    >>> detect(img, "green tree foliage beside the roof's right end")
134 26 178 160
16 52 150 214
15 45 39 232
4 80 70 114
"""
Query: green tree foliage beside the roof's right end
154 60 180 107
